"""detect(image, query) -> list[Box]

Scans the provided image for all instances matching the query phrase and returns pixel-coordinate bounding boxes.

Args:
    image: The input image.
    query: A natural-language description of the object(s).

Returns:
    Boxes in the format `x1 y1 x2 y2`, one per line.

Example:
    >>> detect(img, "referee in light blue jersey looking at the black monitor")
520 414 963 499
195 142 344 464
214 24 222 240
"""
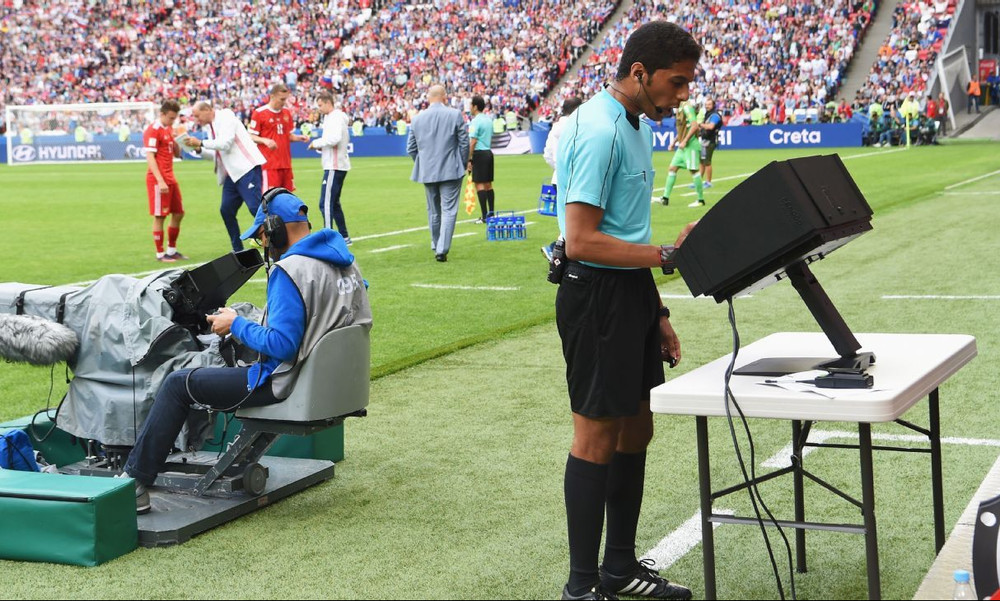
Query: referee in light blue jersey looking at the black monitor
556 21 702 599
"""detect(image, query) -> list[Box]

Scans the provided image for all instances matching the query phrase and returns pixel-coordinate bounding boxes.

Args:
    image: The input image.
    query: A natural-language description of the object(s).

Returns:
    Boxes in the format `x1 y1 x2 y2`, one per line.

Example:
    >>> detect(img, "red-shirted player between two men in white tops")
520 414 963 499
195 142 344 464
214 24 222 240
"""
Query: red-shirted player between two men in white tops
247 83 309 191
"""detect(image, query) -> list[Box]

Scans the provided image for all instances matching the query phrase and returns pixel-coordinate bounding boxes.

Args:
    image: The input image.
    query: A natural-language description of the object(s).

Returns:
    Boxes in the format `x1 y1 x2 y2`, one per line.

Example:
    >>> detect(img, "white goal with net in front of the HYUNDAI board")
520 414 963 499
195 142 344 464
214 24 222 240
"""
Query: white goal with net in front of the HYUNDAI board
4 102 157 165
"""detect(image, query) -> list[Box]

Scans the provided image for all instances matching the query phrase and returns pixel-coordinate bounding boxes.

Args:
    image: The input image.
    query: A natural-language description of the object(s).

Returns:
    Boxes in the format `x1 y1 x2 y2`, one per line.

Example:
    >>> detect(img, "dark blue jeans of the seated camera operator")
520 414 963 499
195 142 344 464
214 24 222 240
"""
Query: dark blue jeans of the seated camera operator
125 367 279 486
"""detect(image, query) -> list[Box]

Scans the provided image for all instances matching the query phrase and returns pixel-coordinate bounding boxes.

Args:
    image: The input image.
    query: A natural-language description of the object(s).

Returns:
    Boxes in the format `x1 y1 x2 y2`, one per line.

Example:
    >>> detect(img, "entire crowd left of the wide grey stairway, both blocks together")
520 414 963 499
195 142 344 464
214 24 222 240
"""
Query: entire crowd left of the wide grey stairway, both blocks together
0 0 616 134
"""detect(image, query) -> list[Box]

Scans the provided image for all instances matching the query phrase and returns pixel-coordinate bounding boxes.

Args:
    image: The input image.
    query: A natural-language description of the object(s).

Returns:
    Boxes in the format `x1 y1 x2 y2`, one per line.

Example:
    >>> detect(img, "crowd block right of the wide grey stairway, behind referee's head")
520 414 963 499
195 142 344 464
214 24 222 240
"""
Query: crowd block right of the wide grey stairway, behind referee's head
544 0 877 122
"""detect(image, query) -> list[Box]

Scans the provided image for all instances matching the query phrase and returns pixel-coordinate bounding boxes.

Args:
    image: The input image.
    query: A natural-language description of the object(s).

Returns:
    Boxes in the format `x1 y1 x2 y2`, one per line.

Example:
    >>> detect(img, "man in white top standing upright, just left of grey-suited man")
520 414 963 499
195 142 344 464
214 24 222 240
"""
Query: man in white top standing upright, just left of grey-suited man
309 92 351 244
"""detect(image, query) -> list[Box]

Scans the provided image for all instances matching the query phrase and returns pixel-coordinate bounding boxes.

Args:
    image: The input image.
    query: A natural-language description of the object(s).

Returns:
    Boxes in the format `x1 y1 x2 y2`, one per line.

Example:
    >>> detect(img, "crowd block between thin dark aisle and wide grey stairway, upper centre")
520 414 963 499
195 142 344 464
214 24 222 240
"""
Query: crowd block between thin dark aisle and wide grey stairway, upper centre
321 0 616 126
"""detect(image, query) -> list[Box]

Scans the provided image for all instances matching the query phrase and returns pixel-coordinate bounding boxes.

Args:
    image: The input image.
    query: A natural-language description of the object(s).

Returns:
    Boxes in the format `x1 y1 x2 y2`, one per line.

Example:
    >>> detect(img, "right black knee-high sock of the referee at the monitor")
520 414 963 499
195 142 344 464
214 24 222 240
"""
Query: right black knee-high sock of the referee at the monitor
604 451 646 576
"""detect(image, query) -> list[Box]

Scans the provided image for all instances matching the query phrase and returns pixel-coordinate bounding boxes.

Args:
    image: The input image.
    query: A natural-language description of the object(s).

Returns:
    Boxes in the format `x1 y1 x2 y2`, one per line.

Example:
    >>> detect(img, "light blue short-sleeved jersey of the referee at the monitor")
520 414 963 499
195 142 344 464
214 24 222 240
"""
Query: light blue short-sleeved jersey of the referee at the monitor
556 90 655 269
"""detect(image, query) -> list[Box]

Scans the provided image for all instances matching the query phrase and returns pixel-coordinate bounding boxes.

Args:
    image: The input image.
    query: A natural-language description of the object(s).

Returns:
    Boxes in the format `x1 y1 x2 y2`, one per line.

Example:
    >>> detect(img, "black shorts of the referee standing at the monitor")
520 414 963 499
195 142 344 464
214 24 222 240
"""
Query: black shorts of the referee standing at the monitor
556 262 664 418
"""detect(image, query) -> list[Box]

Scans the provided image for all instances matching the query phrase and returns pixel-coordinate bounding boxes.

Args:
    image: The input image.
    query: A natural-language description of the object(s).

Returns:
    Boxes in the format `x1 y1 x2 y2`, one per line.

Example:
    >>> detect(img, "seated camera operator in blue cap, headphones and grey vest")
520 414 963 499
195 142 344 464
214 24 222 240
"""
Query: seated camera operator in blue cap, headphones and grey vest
122 188 372 513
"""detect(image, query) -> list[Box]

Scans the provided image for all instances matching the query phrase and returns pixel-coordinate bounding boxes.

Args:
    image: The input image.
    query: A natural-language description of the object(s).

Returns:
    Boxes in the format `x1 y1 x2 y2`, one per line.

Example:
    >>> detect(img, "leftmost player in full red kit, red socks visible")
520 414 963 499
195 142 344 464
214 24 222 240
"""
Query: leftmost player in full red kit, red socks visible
142 100 187 263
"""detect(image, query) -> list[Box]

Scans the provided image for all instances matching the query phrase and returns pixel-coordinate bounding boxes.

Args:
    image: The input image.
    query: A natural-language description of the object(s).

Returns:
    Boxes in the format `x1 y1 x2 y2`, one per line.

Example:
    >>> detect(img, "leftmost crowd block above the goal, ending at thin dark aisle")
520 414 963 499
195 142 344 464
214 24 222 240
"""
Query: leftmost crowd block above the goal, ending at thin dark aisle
0 0 373 127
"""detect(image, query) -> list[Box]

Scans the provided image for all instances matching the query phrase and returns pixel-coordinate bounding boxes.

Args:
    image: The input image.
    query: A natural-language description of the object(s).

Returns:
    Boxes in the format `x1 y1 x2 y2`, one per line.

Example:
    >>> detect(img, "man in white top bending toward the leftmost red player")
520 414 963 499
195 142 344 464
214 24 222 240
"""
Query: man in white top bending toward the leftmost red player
188 100 265 252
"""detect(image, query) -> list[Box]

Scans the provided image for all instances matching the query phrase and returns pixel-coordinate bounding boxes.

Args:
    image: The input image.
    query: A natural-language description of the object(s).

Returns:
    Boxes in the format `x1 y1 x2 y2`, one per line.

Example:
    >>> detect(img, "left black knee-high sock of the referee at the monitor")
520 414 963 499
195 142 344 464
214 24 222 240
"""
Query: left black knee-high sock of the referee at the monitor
563 455 608 596
